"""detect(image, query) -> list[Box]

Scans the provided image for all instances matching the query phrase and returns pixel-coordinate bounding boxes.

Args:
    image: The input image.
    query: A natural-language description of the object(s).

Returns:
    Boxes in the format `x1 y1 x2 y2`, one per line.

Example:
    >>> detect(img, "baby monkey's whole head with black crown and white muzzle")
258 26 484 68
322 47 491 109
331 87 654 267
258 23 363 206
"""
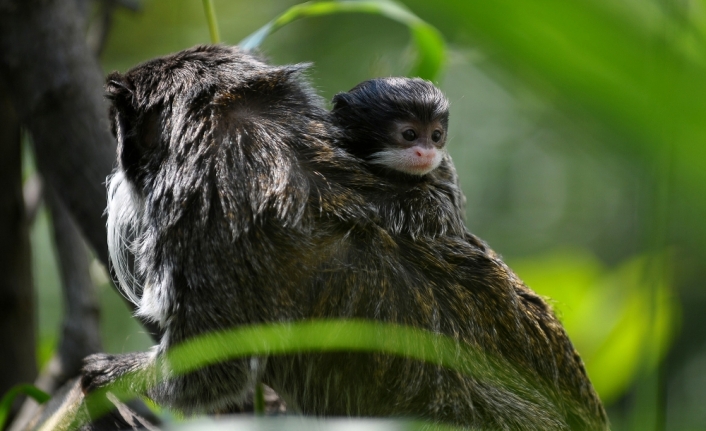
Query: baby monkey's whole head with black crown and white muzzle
332 78 449 176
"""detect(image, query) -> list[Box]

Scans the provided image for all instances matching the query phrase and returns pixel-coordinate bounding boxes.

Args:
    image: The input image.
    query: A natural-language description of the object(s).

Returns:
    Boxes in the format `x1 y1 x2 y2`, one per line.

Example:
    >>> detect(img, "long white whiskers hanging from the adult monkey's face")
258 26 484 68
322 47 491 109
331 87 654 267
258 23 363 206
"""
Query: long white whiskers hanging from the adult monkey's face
105 170 144 305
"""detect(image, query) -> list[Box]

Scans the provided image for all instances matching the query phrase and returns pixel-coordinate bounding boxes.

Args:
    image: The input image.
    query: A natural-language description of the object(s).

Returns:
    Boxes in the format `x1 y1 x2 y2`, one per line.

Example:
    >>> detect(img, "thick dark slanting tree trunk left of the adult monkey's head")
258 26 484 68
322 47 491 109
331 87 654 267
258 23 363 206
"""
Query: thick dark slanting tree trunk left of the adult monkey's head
0 0 115 264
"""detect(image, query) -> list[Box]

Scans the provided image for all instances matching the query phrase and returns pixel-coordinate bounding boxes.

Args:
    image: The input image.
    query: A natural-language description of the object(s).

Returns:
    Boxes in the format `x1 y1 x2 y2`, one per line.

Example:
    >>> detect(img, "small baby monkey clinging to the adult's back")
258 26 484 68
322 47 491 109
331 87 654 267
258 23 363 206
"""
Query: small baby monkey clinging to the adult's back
331 77 468 240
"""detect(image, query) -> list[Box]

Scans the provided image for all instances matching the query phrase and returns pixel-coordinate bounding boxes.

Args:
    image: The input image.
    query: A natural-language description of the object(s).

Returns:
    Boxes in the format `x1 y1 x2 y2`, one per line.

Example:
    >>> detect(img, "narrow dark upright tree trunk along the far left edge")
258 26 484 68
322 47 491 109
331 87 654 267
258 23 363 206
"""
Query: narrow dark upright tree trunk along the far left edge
0 85 37 416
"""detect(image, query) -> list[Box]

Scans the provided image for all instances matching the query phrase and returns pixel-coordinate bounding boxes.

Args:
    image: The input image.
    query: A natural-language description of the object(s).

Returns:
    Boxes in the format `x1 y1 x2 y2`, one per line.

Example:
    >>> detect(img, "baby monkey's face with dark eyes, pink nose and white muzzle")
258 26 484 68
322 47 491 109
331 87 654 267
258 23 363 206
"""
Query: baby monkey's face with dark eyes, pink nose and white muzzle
370 120 446 175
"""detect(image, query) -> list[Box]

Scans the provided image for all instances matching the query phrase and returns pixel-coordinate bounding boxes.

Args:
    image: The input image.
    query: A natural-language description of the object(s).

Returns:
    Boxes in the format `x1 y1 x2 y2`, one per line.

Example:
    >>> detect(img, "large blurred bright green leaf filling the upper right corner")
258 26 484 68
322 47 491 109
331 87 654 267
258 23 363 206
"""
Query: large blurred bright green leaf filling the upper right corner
408 0 706 216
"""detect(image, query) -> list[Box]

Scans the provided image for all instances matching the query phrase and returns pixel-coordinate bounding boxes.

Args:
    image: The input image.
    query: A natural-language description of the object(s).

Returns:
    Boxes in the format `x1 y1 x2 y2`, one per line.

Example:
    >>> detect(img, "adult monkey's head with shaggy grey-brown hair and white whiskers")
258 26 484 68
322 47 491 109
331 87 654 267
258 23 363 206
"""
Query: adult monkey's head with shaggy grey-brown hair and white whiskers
106 46 324 321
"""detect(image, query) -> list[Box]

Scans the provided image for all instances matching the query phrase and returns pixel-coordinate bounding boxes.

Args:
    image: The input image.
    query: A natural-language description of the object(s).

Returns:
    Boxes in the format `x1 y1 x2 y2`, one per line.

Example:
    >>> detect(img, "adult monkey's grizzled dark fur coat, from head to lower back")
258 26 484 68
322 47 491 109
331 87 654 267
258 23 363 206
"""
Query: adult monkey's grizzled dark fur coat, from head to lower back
83 46 606 430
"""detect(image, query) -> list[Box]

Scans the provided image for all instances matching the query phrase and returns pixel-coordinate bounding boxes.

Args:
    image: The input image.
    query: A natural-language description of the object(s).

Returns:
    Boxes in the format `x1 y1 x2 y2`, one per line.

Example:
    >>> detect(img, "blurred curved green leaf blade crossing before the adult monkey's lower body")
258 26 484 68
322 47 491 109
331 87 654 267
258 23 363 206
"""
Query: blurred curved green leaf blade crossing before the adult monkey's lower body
81 320 552 424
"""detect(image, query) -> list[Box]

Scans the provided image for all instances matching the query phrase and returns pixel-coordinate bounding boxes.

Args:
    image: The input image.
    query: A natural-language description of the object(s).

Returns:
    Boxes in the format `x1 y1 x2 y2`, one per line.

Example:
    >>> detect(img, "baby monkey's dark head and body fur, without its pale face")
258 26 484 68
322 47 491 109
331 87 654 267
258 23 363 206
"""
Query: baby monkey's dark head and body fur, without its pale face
331 77 466 237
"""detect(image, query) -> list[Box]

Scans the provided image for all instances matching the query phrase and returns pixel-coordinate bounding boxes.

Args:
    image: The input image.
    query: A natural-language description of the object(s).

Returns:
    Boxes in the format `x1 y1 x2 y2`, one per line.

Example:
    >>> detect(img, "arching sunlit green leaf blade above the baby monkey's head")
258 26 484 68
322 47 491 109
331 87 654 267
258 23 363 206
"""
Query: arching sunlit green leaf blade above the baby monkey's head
239 0 446 81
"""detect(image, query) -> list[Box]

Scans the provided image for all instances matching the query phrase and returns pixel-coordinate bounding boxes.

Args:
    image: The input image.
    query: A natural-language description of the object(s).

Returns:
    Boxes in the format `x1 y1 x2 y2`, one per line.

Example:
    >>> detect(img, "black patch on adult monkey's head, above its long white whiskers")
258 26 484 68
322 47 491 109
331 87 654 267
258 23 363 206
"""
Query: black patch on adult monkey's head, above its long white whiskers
106 72 158 182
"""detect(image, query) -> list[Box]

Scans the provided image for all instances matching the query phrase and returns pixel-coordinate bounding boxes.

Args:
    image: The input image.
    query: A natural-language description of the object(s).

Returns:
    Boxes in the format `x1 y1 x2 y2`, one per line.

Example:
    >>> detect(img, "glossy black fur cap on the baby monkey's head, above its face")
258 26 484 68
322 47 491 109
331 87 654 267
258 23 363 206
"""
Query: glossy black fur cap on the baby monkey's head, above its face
331 77 449 160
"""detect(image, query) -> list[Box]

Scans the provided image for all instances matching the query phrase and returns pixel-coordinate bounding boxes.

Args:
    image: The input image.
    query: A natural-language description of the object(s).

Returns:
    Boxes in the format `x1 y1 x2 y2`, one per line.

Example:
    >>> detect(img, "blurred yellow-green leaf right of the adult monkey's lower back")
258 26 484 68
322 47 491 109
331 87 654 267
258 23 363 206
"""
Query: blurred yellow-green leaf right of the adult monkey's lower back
513 250 678 404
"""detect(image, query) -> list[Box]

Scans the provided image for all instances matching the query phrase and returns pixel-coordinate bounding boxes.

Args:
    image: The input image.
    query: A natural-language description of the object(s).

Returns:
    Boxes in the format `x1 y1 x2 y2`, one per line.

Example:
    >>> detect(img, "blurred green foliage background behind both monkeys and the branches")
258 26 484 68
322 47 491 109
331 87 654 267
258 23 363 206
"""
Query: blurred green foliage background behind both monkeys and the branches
20 0 706 430
